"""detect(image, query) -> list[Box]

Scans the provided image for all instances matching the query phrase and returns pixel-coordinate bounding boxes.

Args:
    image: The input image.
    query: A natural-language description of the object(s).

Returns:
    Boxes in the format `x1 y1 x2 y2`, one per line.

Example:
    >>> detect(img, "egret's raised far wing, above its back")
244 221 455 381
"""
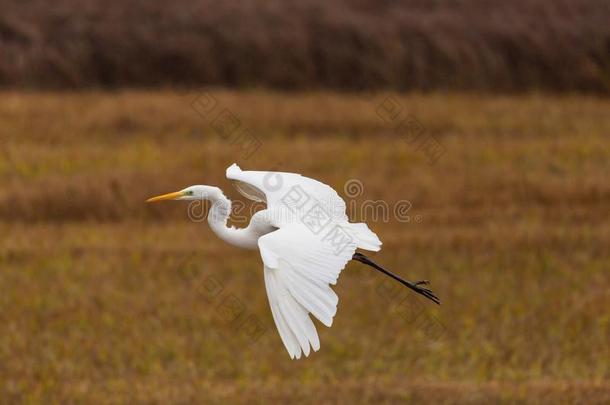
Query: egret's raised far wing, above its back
227 163 348 221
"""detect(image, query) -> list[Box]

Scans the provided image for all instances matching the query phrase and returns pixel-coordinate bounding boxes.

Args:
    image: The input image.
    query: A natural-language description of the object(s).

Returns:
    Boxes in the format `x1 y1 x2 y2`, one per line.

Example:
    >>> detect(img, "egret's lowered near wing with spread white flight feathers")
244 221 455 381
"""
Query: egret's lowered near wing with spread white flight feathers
258 224 356 359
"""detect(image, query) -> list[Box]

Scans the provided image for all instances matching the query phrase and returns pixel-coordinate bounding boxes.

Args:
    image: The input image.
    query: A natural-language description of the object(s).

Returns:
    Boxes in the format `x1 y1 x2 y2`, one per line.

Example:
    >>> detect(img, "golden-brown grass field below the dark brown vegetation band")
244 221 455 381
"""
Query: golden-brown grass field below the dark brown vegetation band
0 91 610 404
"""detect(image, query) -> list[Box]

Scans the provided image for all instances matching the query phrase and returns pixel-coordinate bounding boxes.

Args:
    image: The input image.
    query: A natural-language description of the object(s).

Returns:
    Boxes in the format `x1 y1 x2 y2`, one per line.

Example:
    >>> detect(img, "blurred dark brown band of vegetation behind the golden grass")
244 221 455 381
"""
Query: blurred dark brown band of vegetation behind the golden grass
0 0 610 94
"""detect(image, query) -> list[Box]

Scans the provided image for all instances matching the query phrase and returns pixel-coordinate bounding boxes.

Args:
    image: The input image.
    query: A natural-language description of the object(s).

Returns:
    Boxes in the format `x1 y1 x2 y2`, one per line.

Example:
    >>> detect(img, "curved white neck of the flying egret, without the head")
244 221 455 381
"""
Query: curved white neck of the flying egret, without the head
208 189 258 249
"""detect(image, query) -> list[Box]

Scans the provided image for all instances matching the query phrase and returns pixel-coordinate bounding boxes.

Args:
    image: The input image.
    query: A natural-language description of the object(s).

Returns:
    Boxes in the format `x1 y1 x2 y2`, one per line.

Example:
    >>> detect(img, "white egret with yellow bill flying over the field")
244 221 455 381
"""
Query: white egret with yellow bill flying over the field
147 164 440 359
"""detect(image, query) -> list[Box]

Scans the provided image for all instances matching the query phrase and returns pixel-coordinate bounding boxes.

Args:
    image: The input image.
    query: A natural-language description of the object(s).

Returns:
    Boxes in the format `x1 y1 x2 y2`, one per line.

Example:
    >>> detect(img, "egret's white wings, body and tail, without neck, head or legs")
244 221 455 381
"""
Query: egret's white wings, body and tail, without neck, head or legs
227 164 381 359
